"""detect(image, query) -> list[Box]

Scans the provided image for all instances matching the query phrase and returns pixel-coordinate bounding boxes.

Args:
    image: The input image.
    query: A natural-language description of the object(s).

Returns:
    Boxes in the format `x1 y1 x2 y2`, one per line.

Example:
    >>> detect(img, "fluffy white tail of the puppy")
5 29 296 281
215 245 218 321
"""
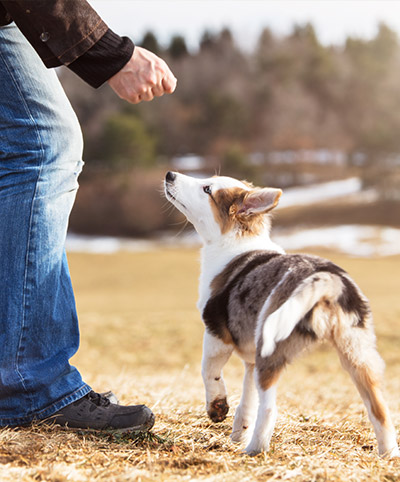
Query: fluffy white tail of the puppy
261 272 344 357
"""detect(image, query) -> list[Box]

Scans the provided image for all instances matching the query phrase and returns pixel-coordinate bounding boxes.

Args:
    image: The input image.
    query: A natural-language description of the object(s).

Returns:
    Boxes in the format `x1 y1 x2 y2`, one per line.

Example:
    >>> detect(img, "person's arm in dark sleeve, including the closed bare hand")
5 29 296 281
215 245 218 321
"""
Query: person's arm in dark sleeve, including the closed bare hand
2 0 176 103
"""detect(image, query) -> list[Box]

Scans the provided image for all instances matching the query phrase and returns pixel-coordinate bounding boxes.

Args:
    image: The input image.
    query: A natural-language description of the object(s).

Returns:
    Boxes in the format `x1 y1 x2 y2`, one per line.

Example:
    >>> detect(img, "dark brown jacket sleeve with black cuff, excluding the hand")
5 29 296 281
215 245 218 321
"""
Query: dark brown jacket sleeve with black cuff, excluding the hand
0 0 134 87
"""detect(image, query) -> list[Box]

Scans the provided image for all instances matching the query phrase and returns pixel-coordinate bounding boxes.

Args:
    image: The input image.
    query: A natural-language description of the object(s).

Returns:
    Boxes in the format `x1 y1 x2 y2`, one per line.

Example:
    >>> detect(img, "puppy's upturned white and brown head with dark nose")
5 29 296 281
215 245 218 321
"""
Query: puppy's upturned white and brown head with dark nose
164 172 282 242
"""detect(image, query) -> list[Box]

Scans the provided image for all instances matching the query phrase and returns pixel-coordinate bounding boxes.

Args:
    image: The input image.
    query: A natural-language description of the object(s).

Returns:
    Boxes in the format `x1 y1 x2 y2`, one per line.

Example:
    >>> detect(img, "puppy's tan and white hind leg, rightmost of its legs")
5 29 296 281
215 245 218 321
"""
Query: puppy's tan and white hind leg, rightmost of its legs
334 315 400 457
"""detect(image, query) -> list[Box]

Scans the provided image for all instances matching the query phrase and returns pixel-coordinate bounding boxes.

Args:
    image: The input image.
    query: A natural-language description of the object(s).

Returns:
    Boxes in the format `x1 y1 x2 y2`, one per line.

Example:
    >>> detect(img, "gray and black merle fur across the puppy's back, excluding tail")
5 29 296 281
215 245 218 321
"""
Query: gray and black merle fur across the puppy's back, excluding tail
203 250 369 348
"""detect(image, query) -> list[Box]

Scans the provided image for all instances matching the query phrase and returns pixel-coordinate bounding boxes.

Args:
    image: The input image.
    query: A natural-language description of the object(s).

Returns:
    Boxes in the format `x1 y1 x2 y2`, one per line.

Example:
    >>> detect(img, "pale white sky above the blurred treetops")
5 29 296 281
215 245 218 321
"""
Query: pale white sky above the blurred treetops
89 0 400 49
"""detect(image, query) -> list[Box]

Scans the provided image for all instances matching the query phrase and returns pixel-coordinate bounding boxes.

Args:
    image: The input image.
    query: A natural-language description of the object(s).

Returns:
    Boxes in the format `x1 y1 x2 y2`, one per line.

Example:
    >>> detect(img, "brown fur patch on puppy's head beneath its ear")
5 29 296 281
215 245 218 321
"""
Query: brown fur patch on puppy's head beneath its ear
210 187 265 236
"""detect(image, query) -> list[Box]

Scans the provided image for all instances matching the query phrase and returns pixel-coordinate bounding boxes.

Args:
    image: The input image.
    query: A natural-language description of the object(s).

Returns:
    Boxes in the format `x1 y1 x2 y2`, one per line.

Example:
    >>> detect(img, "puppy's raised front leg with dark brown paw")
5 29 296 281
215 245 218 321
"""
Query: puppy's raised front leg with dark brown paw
201 330 233 422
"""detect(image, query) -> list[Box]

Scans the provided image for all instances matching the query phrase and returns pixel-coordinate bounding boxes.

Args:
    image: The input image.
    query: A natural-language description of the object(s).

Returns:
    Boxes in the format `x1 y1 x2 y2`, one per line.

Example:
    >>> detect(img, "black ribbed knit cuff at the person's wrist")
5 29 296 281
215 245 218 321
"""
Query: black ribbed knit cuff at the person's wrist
67 29 135 89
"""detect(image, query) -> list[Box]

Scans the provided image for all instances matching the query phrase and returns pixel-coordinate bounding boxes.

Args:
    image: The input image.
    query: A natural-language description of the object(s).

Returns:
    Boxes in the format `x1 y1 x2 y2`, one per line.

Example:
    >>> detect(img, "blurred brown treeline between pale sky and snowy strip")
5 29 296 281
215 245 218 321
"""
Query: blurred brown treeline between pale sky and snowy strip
62 24 400 170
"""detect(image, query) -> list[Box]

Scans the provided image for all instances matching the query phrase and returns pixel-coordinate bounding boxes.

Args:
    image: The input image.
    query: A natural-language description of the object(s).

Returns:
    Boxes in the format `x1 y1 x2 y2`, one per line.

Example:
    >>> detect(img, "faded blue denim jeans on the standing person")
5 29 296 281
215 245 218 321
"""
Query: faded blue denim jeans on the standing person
0 24 90 426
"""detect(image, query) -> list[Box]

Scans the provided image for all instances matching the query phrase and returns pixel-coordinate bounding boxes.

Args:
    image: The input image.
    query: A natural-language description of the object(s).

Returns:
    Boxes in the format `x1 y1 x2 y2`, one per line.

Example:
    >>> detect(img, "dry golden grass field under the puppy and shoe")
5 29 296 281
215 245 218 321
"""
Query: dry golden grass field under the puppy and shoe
0 250 400 482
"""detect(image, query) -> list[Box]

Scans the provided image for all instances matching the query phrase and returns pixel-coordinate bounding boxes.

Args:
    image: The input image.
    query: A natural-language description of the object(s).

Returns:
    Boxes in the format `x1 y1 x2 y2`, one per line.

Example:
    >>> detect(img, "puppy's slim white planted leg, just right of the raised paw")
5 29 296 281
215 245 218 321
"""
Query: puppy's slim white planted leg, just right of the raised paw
231 362 258 442
